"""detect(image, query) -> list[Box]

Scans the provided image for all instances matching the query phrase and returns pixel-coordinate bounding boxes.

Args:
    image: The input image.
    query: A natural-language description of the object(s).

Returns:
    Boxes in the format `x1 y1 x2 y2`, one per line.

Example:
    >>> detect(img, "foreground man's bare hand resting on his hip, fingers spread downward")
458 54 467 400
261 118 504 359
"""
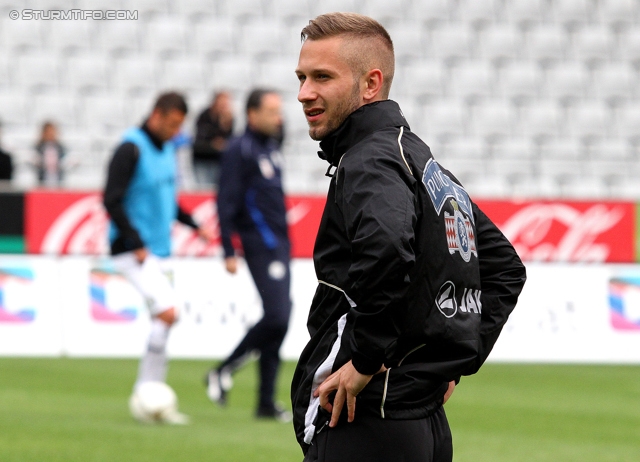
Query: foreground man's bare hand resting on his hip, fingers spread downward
313 361 373 428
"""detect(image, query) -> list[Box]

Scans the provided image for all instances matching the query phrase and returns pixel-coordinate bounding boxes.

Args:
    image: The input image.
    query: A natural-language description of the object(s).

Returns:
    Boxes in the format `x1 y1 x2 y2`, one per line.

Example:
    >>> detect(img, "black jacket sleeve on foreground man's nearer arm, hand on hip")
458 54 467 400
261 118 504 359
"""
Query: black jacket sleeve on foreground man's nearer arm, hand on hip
337 152 417 374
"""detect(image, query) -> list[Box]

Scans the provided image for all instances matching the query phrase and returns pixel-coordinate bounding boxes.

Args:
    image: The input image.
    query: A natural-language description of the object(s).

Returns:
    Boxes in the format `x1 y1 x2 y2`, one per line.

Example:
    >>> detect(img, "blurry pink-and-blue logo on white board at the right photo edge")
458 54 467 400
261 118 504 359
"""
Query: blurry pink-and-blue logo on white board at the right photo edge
609 275 640 331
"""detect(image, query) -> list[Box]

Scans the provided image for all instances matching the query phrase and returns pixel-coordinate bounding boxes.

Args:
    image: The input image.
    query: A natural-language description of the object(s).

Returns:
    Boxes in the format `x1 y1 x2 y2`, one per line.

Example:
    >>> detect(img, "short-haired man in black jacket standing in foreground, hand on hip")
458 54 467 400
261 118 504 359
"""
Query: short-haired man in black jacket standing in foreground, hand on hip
291 13 525 462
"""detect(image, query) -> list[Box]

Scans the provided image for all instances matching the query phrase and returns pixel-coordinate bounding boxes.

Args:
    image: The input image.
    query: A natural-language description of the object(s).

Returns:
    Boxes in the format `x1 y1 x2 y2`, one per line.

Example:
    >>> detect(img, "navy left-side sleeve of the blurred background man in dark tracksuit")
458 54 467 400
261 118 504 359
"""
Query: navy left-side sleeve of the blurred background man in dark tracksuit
217 139 244 257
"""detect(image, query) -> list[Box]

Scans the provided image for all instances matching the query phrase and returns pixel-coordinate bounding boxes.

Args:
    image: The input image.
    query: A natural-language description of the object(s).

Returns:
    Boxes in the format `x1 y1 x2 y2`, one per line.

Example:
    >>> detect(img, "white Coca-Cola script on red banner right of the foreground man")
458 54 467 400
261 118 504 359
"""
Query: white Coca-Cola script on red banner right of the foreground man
500 203 625 262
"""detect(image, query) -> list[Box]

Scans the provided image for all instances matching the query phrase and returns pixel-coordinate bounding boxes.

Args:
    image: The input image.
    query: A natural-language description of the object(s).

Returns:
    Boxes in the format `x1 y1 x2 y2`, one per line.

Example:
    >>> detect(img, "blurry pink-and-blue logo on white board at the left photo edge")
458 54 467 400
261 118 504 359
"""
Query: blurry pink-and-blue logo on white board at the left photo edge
0 267 36 323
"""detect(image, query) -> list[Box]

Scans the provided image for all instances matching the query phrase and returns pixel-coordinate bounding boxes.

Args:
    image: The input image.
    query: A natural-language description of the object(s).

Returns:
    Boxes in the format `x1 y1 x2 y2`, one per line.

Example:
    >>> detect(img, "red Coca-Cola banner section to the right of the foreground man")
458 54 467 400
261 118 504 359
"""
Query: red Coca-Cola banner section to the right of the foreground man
477 201 636 263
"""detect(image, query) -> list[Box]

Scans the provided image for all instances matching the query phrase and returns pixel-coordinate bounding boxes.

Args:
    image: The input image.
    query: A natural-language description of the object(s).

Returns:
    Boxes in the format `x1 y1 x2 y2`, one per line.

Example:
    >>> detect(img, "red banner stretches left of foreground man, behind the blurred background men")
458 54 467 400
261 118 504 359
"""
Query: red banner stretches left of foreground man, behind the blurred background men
25 190 325 258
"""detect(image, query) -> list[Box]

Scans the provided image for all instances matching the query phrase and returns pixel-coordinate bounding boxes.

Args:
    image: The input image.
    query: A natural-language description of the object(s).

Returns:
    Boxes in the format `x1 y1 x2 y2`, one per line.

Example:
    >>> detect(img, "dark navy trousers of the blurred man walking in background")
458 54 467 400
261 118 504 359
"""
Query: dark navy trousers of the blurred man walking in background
219 249 291 408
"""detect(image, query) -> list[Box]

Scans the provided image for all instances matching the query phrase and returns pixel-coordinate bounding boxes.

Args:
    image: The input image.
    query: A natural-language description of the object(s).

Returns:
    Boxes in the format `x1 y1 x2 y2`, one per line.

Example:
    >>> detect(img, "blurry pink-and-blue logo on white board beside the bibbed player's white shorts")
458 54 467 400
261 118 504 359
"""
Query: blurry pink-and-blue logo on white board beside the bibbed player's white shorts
89 268 138 322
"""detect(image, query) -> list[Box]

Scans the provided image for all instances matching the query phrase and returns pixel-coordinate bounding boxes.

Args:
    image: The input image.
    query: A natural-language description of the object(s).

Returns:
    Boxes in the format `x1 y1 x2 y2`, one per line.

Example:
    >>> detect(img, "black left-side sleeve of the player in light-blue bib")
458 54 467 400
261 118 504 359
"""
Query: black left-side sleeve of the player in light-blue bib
103 143 144 250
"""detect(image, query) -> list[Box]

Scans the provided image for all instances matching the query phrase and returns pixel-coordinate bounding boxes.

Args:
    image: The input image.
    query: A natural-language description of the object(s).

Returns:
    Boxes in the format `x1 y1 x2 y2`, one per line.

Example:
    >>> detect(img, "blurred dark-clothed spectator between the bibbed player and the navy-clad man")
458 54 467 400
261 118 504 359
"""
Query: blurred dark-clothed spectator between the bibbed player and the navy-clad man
193 91 238 186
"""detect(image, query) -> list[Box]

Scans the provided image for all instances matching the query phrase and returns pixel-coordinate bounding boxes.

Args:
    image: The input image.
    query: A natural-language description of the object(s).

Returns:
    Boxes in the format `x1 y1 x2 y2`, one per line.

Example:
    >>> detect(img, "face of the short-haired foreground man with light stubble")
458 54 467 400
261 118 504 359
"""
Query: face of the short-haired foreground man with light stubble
296 37 363 141
